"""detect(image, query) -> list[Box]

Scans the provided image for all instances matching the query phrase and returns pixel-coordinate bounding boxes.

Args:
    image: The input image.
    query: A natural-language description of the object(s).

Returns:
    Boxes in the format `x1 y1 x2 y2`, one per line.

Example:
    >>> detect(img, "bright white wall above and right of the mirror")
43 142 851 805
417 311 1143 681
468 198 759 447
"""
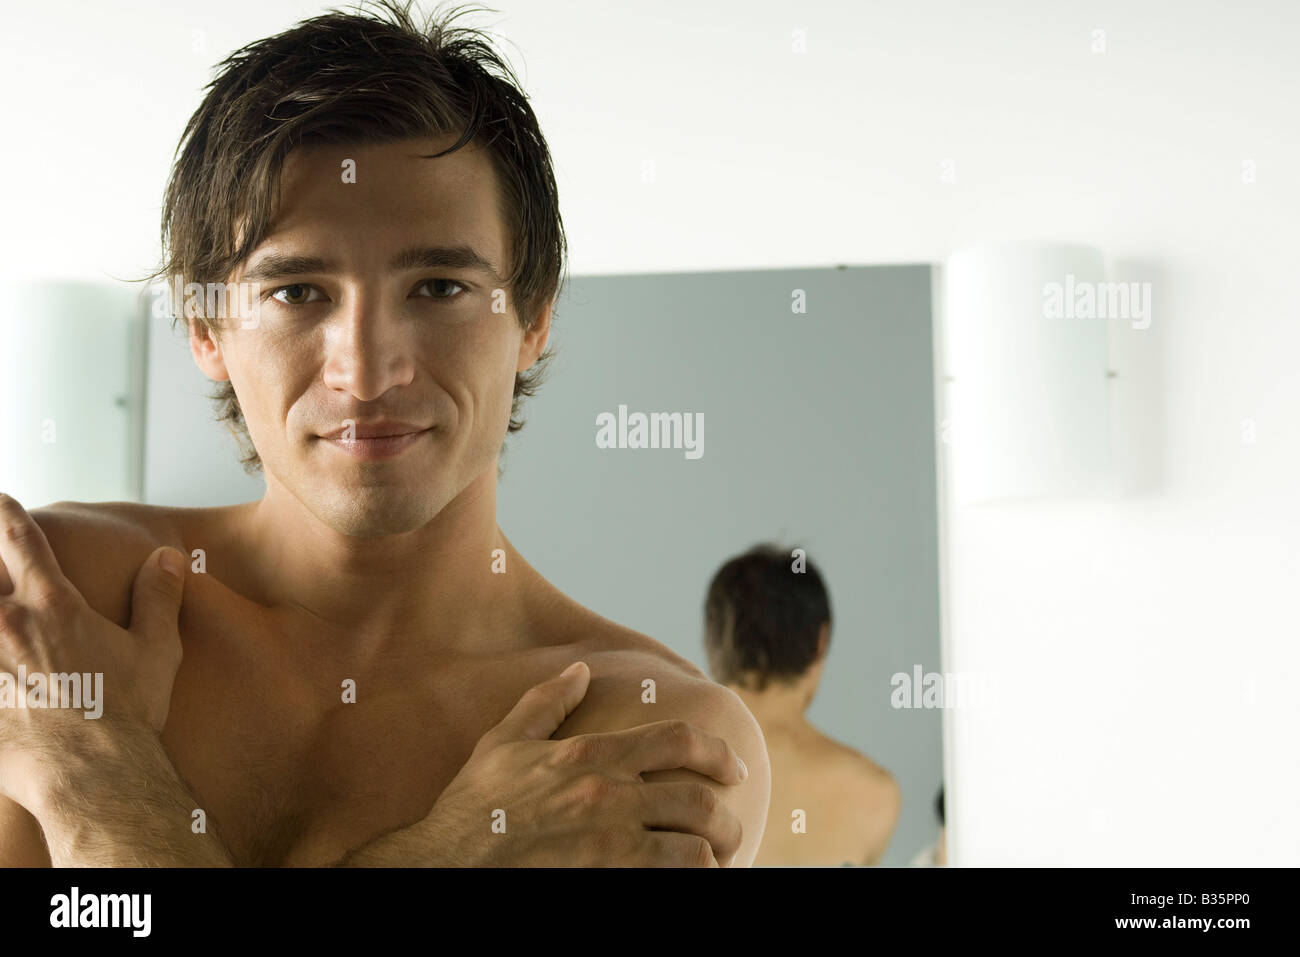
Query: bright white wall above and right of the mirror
0 0 1300 865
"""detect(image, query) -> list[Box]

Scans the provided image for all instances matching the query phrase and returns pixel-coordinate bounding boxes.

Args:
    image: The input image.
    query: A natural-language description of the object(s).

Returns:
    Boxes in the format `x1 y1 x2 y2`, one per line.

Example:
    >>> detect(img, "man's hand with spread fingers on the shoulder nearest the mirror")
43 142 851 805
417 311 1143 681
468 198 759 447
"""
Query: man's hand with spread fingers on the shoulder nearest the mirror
342 662 748 867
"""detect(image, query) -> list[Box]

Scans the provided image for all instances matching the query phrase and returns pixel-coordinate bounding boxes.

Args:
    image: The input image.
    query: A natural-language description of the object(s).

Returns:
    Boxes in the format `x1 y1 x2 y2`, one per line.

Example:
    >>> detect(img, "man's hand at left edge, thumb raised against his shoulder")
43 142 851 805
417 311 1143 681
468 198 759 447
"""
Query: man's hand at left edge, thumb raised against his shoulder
0 493 185 804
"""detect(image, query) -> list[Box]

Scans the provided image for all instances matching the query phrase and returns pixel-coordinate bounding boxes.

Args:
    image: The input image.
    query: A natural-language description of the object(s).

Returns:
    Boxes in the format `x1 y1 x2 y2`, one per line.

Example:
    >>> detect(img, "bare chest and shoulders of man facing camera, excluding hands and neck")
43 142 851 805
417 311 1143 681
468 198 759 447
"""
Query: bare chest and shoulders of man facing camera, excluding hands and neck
0 503 766 866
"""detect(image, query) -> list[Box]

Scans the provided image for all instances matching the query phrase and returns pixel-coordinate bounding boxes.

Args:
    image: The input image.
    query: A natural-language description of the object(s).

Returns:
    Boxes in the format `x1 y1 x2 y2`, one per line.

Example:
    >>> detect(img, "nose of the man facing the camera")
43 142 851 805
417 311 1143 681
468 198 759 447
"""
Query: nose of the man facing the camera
324 298 415 402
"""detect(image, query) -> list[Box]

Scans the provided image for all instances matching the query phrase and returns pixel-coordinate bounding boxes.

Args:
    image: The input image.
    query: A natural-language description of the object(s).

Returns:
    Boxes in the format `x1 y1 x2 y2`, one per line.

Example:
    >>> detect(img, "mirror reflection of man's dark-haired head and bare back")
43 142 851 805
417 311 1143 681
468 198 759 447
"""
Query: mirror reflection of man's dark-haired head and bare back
705 545 901 866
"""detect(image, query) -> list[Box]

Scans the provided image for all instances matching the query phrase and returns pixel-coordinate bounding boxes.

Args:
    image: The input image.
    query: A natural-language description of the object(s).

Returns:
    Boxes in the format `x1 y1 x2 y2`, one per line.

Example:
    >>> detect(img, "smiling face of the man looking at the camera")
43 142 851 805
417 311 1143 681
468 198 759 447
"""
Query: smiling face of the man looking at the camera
191 139 550 537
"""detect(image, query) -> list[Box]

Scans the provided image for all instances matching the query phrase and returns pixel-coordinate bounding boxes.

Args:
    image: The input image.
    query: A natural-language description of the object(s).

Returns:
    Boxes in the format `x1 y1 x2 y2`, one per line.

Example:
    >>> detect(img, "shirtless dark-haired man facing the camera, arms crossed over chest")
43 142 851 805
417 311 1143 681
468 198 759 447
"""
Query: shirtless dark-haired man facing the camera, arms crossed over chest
0 4 768 865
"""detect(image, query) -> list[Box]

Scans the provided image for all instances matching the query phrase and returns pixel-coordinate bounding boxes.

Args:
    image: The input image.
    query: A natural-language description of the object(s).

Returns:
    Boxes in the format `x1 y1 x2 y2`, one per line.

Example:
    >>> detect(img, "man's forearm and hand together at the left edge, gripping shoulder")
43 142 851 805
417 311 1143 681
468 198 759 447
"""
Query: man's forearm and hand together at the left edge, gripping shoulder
0 495 229 866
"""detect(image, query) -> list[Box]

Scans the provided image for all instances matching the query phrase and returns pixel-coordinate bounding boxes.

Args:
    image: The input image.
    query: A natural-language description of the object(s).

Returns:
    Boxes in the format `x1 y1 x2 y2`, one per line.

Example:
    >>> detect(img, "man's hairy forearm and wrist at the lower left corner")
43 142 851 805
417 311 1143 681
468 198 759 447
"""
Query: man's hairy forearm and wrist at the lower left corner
12 719 231 867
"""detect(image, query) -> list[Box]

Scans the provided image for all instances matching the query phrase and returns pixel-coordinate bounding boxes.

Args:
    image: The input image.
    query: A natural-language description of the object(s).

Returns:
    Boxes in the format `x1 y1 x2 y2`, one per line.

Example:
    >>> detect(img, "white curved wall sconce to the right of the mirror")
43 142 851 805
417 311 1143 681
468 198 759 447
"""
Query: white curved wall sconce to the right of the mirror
943 242 1113 505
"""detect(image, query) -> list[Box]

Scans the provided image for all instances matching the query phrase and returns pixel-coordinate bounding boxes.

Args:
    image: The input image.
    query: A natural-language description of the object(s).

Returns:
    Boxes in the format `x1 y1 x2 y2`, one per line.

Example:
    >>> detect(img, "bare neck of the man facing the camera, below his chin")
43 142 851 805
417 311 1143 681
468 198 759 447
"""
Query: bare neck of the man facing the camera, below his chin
228 465 537 651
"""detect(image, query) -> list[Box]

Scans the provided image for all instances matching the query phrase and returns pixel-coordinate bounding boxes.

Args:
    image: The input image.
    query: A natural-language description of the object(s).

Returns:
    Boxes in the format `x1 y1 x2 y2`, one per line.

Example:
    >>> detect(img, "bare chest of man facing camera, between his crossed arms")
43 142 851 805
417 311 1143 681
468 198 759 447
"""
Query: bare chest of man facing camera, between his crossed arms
154 590 582 866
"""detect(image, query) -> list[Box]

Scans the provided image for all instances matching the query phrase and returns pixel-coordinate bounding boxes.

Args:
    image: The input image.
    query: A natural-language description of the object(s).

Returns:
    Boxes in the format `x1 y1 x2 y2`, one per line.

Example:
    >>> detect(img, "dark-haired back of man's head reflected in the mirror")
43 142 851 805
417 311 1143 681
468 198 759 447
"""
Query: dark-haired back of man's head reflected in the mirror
705 545 831 690
